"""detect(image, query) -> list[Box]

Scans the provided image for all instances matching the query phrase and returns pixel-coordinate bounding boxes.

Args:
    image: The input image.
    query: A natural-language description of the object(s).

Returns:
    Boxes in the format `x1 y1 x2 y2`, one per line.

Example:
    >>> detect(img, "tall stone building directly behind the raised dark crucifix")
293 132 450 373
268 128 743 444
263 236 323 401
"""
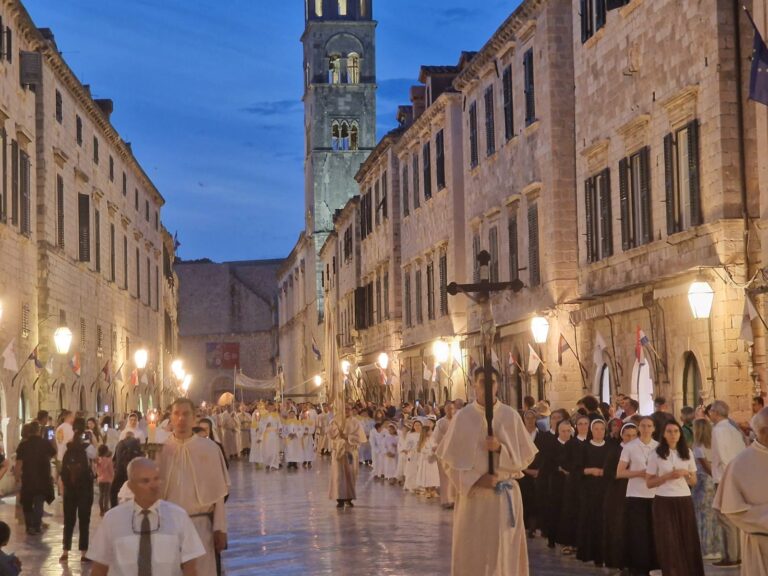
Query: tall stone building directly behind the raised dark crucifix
453 0 583 407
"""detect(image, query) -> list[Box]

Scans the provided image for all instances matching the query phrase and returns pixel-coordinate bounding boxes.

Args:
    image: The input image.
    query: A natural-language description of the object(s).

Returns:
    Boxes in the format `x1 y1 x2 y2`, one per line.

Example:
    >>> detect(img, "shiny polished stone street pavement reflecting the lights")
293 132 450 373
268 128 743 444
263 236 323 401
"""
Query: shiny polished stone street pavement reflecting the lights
0 462 738 576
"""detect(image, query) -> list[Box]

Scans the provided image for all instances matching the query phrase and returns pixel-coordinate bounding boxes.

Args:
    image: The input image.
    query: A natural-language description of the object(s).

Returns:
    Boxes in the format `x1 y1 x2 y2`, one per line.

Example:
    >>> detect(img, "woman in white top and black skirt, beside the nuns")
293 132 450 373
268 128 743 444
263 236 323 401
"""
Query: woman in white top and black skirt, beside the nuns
616 416 659 574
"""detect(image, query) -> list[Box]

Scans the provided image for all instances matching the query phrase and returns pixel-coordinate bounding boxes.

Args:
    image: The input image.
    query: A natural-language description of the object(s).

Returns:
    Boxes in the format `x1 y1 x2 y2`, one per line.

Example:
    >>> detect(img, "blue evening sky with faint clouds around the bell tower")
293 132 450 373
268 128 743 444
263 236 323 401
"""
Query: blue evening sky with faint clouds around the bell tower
24 0 519 261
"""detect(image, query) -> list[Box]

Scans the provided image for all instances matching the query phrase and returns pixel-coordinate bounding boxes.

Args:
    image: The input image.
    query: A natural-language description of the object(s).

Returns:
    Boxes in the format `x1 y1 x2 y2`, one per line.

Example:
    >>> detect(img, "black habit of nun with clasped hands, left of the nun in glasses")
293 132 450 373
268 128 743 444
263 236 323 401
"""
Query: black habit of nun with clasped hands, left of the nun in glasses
576 441 610 566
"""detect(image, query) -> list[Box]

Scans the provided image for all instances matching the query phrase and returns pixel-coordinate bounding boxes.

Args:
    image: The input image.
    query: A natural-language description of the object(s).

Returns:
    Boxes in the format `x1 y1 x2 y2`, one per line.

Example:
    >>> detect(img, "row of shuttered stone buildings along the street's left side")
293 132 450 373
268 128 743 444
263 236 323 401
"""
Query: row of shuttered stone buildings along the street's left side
0 0 175 456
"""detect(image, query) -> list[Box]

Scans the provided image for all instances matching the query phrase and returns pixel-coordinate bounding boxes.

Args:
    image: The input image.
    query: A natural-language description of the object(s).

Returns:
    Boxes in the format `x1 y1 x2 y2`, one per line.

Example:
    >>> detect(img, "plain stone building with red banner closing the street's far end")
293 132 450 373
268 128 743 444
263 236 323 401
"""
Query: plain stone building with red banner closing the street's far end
174 260 283 402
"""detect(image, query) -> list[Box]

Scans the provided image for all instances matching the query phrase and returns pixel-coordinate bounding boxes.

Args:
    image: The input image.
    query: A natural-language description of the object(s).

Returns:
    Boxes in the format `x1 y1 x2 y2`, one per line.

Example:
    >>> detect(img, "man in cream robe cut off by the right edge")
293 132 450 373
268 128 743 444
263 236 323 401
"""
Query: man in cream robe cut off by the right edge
712 408 768 576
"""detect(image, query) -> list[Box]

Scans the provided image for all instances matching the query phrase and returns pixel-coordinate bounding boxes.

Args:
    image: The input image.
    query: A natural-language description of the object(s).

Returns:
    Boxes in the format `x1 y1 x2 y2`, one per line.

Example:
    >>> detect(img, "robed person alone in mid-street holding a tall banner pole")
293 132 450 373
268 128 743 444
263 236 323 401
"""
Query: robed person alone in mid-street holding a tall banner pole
328 406 367 508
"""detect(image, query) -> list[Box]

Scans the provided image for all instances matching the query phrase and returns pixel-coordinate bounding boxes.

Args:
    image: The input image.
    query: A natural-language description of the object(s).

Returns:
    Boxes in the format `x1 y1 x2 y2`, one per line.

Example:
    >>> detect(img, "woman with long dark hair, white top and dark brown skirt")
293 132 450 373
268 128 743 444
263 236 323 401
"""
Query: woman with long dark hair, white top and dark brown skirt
646 421 704 576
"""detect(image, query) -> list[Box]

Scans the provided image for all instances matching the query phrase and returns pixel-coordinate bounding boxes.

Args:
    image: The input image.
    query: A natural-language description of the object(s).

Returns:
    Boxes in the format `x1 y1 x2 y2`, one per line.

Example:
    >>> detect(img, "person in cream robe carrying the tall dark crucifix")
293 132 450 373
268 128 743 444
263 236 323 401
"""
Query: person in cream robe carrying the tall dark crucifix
437 369 537 576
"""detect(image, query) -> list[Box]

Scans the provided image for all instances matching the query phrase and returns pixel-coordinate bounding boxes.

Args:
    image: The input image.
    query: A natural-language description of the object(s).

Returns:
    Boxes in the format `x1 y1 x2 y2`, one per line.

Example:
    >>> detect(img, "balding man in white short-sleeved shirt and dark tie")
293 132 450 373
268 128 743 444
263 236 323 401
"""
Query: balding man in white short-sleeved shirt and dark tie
88 458 205 576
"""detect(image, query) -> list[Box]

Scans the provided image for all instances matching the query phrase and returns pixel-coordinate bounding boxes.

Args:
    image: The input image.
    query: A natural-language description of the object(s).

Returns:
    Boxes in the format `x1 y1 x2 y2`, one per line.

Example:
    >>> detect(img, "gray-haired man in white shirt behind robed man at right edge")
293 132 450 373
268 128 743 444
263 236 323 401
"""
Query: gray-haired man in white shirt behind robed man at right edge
709 400 746 567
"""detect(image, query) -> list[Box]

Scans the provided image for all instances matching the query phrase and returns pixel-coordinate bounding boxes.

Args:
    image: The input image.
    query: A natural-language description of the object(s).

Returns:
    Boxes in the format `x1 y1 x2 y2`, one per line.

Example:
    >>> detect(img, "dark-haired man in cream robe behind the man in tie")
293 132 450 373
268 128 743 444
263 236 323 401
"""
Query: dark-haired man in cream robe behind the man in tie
159 398 230 576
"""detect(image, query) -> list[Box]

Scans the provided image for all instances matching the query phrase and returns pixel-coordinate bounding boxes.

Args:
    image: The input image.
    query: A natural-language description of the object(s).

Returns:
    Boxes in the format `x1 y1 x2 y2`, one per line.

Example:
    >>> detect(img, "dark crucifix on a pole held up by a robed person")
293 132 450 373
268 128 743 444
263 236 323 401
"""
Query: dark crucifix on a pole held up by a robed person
448 250 524 475
